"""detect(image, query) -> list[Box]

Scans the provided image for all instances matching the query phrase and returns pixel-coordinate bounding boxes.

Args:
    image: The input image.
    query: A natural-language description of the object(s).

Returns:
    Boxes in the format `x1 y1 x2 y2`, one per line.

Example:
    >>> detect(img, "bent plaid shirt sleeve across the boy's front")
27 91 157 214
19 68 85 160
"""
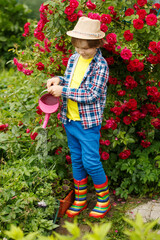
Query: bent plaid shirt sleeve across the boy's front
62 64 109 104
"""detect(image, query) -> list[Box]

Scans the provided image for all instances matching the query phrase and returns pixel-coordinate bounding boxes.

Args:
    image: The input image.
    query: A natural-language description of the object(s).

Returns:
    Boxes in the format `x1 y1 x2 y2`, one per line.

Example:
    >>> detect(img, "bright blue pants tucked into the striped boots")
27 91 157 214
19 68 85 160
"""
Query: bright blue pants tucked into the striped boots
64 120 106 185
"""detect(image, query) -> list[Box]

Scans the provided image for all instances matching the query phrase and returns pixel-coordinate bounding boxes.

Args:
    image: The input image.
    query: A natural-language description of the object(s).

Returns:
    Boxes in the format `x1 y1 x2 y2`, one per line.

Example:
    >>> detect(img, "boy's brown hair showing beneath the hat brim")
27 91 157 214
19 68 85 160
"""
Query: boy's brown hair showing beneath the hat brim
71 37 104 48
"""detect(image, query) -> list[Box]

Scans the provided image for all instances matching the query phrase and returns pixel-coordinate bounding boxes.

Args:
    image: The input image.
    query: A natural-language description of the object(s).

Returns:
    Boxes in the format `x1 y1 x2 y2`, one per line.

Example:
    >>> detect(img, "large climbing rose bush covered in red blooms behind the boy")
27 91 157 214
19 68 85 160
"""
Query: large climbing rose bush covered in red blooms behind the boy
2 0 160 197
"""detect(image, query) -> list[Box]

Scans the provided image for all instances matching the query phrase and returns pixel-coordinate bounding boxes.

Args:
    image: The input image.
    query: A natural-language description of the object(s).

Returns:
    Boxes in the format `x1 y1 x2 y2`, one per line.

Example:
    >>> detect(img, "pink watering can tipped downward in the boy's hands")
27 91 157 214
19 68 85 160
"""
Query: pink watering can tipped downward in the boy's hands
38 90 59 128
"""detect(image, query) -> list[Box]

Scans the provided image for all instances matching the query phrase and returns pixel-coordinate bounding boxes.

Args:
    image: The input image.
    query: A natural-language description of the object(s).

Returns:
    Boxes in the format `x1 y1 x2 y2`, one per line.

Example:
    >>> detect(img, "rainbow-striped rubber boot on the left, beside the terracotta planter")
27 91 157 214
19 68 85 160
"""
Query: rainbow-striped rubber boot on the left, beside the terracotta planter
66 177 88 217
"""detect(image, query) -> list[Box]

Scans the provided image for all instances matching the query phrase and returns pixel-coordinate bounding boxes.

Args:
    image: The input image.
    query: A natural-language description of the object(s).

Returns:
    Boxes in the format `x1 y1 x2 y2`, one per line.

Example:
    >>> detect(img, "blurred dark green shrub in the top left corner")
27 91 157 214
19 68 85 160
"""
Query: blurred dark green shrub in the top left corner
0 0 30 68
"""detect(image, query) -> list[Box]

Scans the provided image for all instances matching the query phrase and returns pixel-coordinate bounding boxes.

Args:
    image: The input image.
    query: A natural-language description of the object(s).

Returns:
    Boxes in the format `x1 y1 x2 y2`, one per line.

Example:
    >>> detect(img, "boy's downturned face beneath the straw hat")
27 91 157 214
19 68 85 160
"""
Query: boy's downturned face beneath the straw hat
75 39 96 59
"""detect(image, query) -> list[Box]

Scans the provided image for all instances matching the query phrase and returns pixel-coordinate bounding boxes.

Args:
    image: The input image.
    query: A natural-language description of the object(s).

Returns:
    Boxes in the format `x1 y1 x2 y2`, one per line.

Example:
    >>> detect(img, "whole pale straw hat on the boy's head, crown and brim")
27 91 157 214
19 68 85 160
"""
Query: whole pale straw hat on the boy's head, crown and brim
67 17 105 40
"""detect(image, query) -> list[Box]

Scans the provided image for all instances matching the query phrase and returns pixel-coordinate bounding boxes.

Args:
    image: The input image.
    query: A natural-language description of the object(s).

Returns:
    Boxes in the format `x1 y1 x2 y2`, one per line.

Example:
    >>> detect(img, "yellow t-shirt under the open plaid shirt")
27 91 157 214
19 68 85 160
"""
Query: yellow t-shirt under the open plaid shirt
67 56 93 120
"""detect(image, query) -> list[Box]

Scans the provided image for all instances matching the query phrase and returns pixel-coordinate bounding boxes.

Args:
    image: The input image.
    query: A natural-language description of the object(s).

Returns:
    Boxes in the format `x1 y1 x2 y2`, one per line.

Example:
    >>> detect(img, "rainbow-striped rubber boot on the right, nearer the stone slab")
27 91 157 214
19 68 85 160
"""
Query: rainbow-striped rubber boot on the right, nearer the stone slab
89 177 111 218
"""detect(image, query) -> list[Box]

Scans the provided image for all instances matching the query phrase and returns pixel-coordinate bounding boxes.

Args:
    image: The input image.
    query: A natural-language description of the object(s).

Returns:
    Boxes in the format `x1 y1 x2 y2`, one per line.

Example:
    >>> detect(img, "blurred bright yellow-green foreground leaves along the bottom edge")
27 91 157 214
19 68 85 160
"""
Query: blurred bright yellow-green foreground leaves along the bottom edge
2 215 160 240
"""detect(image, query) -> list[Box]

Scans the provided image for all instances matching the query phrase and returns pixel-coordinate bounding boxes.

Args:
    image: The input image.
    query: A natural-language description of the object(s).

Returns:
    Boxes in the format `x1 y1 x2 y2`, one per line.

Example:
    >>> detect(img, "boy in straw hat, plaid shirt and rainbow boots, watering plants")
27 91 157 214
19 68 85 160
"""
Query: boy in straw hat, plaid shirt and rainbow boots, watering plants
47 17 111 218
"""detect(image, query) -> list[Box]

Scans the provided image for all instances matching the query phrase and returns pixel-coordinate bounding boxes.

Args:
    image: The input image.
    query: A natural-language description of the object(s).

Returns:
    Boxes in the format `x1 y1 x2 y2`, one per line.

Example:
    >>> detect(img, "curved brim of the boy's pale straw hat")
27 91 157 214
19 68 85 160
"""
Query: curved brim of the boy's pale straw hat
66 31 105 40
